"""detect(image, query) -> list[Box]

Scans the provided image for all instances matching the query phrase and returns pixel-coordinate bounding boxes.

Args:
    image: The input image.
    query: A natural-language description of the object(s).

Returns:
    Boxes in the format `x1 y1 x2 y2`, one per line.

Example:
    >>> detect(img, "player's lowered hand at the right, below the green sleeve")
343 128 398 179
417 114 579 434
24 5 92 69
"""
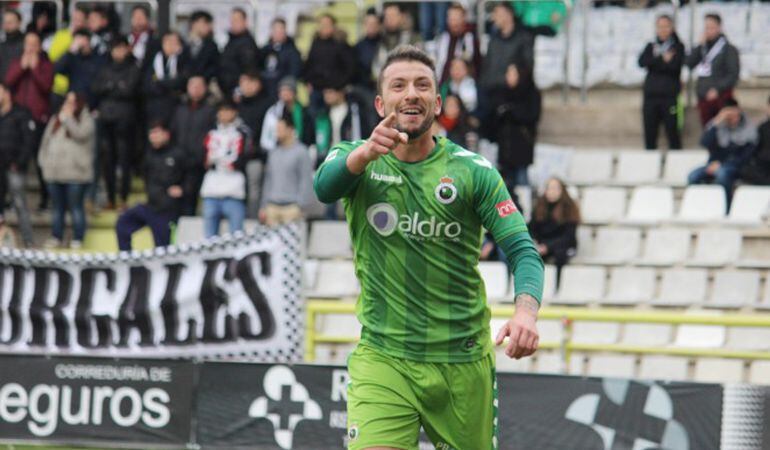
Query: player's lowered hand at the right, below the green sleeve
495 294 540 359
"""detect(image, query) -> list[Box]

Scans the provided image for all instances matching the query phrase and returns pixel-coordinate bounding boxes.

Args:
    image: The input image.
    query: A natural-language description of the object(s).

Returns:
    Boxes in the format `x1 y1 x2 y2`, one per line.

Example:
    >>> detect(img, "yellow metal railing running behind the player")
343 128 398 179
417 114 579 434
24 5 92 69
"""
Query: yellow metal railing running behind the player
305 300 770 368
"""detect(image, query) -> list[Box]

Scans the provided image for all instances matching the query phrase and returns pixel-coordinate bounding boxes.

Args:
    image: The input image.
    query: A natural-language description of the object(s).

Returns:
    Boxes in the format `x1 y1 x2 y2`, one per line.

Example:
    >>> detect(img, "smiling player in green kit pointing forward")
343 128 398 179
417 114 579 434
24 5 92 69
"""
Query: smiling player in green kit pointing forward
314 46 543 450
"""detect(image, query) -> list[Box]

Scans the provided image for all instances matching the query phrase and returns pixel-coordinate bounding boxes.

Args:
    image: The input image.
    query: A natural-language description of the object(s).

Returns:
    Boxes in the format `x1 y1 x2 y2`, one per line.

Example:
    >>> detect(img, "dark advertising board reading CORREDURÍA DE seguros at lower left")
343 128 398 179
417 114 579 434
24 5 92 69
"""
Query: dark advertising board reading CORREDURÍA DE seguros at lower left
0 356 196 448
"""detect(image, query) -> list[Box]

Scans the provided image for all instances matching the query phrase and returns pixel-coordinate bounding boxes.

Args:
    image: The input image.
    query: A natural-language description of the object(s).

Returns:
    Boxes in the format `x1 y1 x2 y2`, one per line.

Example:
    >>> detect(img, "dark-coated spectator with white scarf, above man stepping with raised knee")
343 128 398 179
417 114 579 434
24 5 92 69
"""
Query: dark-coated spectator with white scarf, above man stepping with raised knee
143 31 187 123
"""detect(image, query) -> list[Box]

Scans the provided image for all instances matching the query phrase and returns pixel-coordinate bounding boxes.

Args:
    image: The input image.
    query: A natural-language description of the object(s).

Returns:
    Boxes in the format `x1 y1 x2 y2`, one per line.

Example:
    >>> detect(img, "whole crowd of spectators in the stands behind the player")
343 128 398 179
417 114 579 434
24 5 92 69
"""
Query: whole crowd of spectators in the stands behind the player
0 2 770 267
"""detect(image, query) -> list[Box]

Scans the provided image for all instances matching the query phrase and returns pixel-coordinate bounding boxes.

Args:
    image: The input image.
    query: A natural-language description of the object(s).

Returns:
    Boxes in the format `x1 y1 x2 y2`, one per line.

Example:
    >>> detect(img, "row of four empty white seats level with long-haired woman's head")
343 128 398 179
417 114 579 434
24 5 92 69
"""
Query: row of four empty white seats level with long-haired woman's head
580 185 770 226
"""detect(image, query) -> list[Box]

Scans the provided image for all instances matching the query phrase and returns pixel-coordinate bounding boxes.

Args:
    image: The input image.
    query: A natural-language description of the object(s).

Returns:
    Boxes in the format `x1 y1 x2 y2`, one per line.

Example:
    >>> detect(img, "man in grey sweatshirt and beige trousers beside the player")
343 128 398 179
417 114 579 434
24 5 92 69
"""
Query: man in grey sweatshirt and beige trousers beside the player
259 110 313 227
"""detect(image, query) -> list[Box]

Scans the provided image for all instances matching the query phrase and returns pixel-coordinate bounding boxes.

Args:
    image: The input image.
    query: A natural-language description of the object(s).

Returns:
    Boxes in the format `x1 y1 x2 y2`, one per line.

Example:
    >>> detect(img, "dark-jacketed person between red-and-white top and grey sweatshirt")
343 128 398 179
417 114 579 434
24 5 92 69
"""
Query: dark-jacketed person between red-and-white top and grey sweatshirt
237 71 271 218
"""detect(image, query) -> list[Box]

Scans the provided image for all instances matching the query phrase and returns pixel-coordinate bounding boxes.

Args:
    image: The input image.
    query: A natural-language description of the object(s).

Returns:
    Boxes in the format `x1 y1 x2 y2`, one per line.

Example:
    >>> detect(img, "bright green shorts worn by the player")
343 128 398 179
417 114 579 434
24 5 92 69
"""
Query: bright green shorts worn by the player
348 344 497 450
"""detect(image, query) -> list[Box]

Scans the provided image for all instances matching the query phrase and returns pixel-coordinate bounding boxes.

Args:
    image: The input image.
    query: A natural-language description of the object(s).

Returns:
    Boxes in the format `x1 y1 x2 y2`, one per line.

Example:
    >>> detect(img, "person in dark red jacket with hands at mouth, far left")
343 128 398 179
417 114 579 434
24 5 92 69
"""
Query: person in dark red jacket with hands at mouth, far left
5 31 54 209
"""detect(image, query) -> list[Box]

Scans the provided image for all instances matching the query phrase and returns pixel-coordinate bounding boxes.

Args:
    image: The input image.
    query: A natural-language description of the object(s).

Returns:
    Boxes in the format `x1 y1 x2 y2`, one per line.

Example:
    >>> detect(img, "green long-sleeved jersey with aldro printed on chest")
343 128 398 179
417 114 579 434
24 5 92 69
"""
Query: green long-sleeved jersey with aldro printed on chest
315 137 542 362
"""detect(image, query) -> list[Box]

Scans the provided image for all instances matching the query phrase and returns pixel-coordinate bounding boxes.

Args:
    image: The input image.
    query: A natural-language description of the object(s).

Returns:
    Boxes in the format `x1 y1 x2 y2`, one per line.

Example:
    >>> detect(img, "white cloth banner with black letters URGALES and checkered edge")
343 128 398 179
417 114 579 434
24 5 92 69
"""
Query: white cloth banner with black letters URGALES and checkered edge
0 224 304 362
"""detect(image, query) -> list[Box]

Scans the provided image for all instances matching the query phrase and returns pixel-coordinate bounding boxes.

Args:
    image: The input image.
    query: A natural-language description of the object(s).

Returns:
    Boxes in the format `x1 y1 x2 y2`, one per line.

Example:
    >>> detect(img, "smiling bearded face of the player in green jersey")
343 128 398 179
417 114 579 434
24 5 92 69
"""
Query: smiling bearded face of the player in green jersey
374 61 441 139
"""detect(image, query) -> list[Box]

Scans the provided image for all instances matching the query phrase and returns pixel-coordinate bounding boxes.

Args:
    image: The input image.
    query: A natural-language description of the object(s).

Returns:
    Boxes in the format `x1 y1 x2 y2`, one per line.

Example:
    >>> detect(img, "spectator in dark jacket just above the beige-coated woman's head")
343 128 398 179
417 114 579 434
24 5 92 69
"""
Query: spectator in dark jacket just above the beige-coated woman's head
56 30 107 107
